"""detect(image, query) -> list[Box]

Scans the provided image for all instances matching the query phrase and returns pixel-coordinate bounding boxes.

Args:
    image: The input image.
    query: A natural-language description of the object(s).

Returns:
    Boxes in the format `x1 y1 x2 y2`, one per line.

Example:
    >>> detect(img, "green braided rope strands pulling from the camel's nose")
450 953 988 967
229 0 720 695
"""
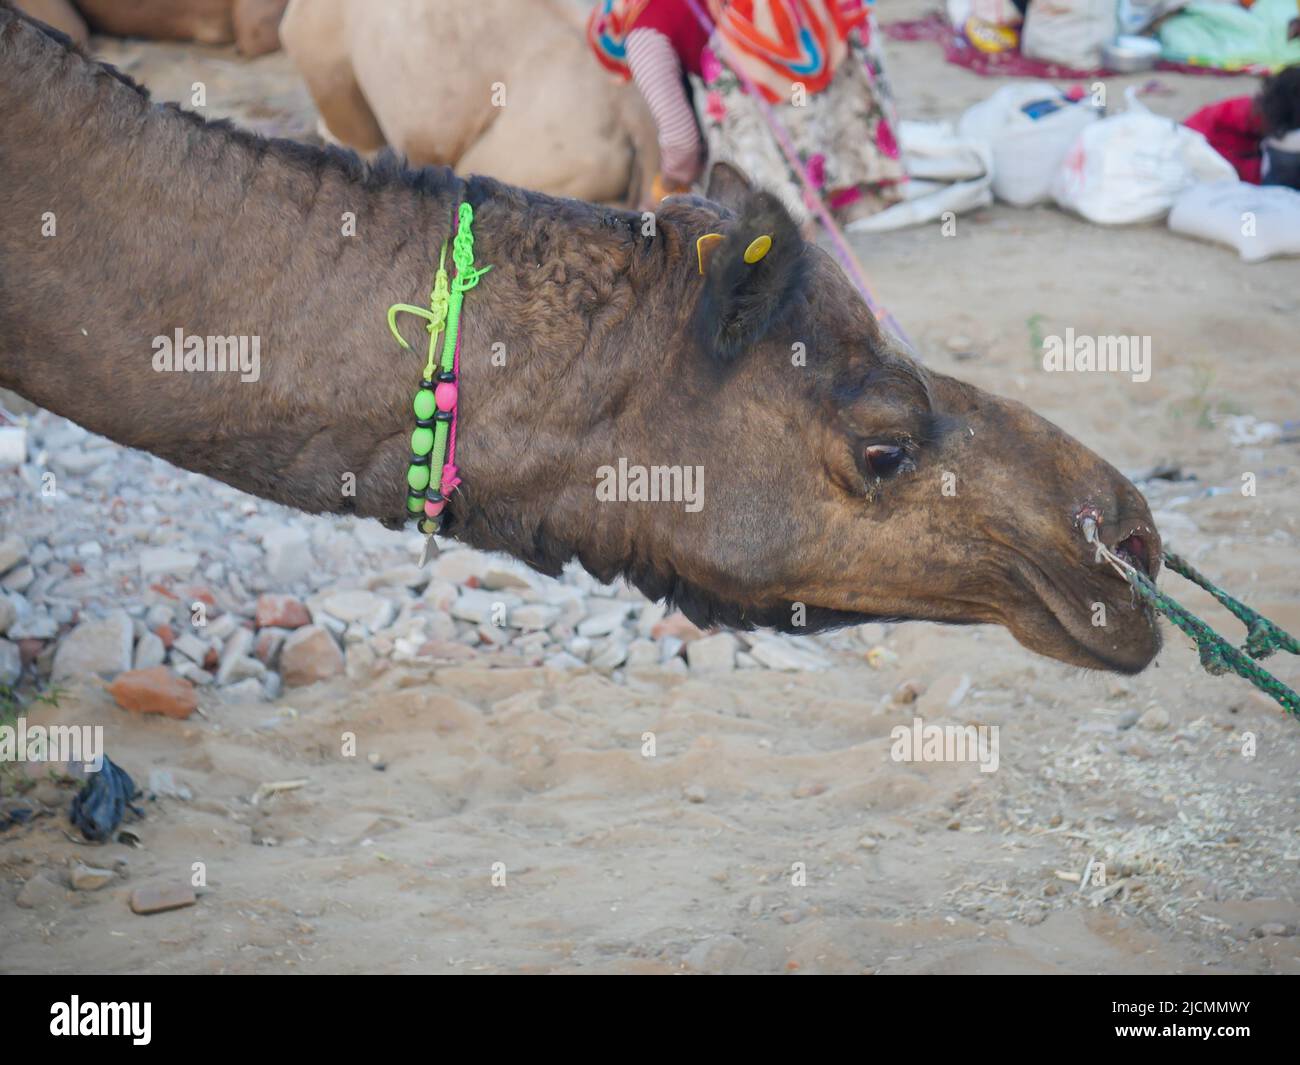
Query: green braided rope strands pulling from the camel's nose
1127 553 1300 718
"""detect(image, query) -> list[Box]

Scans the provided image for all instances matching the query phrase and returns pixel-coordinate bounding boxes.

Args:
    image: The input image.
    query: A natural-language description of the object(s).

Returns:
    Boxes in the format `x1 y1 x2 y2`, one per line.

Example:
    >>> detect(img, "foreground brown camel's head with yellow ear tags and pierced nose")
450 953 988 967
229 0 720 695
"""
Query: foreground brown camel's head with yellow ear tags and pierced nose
572 172 1161 672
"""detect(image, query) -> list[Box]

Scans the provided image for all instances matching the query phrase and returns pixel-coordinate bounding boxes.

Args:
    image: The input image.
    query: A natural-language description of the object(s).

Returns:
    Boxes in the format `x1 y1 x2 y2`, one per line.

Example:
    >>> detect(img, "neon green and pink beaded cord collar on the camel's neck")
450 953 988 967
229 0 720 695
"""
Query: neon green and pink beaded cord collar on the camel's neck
389 203 491 558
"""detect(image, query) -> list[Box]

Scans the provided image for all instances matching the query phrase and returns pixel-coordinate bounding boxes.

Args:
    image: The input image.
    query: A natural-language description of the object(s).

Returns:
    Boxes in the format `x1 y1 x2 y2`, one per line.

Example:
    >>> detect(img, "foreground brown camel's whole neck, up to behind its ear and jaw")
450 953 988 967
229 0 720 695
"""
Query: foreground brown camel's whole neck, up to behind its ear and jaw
0 7 686 564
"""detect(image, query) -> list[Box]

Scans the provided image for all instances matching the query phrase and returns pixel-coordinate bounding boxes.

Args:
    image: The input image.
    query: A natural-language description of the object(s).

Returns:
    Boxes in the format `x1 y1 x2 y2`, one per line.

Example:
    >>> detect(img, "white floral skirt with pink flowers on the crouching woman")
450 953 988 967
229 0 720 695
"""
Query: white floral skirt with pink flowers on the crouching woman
692 24 906 222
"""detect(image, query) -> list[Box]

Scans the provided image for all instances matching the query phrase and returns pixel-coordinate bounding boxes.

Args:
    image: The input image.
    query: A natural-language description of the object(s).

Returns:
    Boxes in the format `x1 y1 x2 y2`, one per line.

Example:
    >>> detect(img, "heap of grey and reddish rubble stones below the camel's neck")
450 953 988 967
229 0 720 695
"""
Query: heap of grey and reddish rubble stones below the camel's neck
0 411 884 702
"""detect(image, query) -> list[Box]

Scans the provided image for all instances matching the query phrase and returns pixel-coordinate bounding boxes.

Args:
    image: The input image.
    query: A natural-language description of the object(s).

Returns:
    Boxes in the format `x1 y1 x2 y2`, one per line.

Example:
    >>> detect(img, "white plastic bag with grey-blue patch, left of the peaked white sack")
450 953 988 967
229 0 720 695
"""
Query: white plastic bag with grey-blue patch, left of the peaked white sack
957 82 1100 207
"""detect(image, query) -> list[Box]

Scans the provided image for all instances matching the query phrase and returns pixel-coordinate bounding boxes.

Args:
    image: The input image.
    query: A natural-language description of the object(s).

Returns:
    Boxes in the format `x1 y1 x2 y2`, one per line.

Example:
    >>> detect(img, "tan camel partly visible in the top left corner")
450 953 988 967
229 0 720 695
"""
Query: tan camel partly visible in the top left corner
17 0 287 56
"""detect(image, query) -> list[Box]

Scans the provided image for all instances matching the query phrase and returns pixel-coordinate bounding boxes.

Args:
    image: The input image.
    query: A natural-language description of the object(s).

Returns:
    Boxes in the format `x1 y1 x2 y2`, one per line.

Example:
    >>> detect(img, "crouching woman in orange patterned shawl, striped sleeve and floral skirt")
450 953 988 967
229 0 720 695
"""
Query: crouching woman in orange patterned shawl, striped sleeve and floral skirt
588 0 906 221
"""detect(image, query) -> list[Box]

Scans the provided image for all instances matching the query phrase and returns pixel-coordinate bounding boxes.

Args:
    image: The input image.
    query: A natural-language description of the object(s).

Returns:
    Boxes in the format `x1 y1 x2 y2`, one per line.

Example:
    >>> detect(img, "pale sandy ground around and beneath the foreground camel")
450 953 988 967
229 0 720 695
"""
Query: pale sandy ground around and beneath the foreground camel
0 4 1300 973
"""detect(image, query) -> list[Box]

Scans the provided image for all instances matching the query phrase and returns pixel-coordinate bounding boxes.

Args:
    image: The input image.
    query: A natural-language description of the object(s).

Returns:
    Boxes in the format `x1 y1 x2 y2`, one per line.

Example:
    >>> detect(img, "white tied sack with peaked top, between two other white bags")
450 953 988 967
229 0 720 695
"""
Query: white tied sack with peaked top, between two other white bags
1052 88 1236 225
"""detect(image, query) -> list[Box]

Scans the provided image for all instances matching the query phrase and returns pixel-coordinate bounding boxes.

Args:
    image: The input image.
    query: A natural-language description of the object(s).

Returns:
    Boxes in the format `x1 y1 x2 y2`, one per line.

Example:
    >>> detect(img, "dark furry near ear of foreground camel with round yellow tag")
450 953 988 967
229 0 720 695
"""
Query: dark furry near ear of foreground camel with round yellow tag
696 192 807 363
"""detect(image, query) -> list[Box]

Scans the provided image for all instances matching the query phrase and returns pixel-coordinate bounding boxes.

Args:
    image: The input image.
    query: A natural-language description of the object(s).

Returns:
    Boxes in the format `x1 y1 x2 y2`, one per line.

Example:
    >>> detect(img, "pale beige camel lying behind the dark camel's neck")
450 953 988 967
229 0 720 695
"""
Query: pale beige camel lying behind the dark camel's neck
280 0 659 207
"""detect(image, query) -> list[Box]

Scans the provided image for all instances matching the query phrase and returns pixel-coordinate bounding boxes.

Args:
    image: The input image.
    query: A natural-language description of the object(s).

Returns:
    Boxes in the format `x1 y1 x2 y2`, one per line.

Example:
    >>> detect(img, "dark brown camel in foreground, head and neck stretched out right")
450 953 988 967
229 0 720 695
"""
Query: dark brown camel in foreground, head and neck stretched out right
0 0 1161 672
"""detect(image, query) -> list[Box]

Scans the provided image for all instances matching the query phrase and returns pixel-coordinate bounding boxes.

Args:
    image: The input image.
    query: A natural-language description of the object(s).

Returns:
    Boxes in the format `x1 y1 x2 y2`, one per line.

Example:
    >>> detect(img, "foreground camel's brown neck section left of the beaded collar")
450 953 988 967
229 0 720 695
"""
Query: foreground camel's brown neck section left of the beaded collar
0 8 460 518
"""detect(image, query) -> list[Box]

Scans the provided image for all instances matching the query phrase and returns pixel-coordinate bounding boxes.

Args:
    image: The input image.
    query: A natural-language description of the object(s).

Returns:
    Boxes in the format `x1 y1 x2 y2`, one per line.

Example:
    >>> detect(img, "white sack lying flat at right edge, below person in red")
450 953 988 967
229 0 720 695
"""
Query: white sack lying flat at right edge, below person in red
1169 181 1300 263
